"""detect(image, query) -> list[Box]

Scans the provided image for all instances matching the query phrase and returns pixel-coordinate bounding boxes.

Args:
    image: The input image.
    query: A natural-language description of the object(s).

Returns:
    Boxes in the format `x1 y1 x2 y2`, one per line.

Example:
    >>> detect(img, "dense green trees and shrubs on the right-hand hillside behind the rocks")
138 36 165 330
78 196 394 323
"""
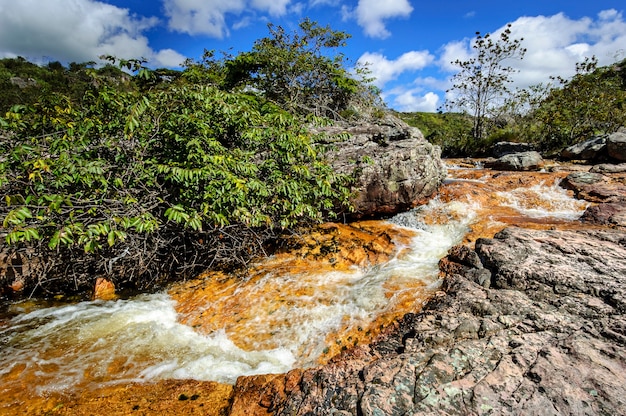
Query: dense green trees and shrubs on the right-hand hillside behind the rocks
399 57 626 157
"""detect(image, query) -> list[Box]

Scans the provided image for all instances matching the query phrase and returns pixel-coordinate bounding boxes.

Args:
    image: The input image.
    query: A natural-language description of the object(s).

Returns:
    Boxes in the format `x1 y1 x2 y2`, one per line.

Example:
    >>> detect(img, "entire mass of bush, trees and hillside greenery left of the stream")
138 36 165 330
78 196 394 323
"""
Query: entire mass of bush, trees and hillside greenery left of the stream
0 21 376 300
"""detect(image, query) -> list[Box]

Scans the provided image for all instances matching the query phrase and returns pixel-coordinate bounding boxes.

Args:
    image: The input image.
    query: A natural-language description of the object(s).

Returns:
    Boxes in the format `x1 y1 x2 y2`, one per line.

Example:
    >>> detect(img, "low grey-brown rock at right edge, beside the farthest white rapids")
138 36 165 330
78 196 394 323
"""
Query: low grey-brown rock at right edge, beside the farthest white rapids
560 172 626 203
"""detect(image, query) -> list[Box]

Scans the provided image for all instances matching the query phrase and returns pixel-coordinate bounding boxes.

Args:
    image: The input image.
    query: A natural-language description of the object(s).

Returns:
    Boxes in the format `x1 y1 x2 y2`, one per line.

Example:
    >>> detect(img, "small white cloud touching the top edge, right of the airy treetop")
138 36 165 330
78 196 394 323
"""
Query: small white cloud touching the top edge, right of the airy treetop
354 0 413 39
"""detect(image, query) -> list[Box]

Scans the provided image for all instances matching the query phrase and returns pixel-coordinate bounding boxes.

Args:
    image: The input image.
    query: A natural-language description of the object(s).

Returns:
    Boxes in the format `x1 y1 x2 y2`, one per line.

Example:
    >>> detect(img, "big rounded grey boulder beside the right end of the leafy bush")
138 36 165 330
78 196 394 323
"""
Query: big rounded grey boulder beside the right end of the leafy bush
318 115 446 217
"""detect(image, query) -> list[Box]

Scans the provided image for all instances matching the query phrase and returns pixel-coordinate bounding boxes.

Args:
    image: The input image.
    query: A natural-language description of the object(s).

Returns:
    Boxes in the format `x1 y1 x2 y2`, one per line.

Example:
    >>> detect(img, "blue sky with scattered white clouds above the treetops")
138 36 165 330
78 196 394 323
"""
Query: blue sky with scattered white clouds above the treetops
0 0 626 112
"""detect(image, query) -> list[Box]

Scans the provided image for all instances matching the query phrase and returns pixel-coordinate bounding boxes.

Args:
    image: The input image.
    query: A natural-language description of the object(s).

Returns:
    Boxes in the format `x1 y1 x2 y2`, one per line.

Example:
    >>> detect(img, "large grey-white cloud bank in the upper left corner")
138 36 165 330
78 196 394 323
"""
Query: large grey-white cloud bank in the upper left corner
0 0 184 66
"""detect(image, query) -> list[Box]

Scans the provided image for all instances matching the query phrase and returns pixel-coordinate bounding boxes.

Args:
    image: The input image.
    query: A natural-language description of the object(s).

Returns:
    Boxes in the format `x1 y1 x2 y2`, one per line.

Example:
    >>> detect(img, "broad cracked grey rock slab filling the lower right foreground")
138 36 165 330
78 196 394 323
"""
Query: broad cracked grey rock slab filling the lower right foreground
240 228 626 416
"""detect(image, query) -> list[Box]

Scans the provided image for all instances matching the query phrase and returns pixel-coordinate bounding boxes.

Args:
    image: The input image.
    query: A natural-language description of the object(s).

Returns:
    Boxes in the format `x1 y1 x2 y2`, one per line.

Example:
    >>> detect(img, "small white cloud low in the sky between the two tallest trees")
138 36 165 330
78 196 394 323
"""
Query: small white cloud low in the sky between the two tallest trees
357 51 435 88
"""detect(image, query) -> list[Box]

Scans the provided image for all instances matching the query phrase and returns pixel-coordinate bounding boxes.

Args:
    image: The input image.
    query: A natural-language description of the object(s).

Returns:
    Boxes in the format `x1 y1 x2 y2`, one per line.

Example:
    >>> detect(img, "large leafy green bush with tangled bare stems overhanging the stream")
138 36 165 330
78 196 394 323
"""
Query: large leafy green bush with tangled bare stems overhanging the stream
0 49 349 292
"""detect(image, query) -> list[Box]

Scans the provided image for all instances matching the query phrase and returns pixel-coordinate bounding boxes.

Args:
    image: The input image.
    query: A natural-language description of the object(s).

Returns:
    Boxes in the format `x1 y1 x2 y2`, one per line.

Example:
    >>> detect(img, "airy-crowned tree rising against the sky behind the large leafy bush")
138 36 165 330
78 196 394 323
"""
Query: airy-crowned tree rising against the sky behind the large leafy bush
183 19 380 119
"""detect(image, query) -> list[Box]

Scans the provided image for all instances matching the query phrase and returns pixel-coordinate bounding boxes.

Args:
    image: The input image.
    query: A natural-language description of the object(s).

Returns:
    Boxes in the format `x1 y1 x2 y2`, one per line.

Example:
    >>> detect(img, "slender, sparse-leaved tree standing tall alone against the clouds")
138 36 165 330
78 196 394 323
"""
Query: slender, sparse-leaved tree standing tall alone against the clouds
446 24 526 140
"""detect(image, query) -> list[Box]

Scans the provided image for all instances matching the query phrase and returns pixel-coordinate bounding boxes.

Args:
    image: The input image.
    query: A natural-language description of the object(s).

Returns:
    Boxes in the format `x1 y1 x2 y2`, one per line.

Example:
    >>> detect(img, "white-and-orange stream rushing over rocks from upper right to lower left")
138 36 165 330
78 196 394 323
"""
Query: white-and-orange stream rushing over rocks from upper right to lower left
0 162 585 394
